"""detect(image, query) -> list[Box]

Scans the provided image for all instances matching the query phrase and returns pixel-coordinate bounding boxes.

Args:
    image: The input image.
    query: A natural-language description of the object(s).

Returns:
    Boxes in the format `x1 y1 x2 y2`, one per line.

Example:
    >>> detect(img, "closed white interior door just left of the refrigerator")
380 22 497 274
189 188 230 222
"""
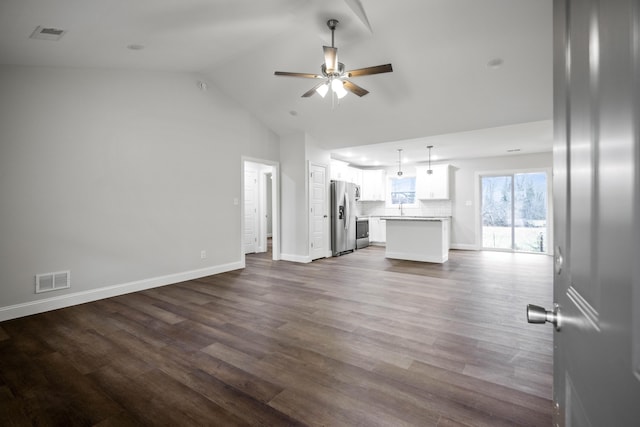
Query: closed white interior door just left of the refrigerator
309 163 329 260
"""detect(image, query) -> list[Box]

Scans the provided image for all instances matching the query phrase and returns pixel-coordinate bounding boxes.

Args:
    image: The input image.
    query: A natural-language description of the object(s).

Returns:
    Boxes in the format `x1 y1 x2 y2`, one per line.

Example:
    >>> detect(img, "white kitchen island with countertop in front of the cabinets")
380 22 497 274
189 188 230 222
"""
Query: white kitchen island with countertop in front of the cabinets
382 216 449 263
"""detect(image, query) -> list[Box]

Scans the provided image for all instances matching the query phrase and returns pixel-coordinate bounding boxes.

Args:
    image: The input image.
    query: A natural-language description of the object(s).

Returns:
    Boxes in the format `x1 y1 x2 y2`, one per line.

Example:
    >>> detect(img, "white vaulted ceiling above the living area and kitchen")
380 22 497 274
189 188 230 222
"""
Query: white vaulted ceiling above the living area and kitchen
0 0 552 165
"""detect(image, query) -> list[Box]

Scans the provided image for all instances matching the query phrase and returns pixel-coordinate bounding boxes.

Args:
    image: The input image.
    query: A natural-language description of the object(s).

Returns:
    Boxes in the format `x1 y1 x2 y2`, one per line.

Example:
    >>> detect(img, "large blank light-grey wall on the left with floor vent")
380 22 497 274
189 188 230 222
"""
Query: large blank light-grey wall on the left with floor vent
0 66 280 320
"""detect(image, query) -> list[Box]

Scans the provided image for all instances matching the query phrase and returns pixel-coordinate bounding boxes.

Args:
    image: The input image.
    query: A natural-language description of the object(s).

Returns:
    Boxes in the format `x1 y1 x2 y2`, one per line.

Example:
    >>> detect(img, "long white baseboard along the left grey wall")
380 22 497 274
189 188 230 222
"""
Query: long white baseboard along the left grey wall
0 261 245 322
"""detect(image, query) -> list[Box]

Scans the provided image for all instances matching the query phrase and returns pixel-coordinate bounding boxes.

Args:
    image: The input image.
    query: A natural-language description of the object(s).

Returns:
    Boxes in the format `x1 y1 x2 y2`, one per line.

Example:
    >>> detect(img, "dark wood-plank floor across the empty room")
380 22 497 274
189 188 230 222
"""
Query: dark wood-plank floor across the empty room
0 247 552 427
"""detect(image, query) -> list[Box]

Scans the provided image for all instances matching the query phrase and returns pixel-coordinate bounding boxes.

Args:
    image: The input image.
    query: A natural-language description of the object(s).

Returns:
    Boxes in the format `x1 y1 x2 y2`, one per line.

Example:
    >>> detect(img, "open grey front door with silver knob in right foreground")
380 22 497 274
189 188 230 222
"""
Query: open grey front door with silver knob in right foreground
528 0 640 427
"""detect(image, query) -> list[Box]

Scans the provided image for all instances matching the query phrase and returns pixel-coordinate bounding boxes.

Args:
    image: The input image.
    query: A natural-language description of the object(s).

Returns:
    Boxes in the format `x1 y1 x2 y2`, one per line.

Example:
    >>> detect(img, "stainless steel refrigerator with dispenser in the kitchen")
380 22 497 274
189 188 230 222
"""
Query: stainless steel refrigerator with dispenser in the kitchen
331 181 358 256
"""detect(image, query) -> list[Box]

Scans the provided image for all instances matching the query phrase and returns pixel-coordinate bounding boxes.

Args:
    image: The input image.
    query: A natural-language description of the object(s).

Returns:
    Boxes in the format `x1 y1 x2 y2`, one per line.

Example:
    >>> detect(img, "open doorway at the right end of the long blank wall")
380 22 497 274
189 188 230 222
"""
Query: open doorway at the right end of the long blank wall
241 158 280 260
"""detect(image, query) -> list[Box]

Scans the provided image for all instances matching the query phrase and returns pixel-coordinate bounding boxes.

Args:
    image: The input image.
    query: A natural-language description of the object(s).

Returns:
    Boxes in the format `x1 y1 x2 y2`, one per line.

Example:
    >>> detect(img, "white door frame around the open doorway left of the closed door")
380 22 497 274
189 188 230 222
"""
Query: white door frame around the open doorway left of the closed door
239 156 280 266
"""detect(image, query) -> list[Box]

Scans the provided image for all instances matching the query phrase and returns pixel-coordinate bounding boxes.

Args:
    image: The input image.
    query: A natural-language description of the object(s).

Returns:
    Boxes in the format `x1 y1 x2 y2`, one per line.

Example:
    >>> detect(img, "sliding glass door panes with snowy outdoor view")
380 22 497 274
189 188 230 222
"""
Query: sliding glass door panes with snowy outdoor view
480 171 549 253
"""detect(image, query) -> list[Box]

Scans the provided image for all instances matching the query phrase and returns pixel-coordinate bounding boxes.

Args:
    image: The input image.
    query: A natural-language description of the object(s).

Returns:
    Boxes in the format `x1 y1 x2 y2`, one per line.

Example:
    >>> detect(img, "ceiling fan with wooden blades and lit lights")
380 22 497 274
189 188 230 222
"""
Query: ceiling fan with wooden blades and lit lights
274 19 393 98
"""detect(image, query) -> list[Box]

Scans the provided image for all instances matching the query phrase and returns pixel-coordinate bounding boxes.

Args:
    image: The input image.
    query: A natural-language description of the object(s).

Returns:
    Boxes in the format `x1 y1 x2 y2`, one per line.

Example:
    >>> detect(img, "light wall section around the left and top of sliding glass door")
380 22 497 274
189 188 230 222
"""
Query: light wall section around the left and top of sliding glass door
451 152 553 249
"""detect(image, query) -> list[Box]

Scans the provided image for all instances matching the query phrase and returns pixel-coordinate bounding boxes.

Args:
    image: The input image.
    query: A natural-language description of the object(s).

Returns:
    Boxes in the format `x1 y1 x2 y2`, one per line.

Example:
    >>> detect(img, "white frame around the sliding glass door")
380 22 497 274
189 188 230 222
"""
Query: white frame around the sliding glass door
474 167 554 256
